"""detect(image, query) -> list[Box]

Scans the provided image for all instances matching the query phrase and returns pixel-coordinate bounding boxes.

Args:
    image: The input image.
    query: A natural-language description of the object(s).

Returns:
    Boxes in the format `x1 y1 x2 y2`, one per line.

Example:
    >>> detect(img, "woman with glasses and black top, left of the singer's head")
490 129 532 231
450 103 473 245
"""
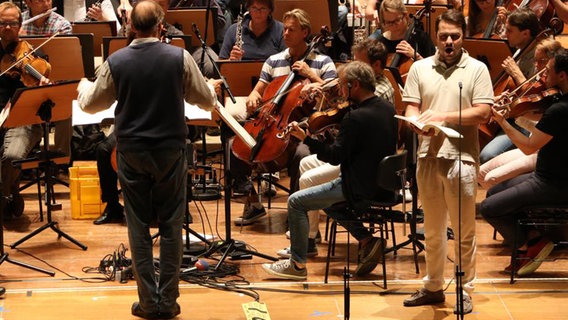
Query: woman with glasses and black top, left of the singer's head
377 0 436 60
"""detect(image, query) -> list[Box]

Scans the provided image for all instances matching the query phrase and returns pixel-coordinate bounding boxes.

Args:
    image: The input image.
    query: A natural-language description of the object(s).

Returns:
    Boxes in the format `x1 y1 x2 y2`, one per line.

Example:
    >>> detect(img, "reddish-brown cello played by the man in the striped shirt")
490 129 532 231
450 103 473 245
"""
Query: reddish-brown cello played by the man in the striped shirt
232 27 327 172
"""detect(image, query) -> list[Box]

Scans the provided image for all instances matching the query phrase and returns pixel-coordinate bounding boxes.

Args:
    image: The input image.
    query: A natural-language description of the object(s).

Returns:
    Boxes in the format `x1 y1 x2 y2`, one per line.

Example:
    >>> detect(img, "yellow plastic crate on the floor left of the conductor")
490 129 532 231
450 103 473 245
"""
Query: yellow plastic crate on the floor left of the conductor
69 161 104 219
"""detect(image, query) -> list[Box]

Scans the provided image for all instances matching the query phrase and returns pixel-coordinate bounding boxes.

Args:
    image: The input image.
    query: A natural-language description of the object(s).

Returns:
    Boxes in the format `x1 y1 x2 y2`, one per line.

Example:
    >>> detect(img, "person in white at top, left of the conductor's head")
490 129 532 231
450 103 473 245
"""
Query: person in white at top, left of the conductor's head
63 0 120 31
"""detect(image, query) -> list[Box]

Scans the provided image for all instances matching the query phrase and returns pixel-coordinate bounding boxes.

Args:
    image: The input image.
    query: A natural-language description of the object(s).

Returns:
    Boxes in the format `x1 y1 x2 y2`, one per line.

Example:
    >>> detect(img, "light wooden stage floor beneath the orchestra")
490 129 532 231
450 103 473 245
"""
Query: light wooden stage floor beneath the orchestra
0 169 568 320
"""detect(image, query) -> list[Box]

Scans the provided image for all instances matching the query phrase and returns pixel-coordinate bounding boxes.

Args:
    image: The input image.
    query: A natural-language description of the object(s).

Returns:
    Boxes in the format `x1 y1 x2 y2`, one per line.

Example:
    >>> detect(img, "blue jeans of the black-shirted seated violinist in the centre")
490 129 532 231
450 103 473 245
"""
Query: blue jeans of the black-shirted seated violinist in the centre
288 178 372 263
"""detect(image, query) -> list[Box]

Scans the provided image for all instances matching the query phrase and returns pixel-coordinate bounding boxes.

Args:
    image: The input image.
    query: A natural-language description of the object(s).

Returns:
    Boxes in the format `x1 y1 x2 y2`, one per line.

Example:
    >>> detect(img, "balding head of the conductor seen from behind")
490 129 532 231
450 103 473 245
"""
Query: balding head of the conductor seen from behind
130 0 165 37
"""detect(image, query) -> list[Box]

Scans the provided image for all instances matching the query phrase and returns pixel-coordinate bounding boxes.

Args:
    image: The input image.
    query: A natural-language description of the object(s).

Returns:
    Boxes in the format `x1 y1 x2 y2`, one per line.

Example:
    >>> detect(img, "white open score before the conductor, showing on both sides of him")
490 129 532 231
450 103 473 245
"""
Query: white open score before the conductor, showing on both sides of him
71 100 213 126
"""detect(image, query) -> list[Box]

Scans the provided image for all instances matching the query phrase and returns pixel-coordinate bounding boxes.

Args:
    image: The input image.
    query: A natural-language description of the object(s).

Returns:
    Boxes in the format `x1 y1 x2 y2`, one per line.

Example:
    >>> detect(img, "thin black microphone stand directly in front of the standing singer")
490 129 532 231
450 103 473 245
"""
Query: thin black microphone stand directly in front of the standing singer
455 81 464 320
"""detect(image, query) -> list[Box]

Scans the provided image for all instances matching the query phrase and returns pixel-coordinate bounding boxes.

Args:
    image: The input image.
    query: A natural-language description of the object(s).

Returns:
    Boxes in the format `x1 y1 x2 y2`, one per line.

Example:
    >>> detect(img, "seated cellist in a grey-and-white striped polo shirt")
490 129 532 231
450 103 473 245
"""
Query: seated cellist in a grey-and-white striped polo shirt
230 9 337 225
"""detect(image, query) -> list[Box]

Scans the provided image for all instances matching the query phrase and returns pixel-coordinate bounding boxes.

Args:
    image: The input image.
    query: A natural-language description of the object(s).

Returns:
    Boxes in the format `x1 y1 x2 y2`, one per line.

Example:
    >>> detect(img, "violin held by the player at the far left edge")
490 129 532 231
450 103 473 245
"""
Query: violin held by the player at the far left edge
0 40 51 87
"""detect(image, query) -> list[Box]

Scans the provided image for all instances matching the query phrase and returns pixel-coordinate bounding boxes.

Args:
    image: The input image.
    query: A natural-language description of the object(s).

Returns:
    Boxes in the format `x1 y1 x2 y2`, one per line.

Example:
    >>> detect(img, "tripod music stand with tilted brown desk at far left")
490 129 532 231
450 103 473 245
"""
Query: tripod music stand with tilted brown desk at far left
2 80 87 250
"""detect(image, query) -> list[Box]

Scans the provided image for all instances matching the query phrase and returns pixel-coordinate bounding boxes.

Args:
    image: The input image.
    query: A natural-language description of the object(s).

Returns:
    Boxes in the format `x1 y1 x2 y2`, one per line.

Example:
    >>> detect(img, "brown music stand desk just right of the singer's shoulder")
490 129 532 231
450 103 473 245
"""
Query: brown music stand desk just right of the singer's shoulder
463 38 512 81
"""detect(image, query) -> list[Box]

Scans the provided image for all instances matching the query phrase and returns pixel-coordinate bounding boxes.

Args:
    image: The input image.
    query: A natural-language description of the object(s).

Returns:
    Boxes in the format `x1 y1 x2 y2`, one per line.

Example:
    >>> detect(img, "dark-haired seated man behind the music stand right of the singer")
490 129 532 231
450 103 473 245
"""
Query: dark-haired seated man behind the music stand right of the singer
479 8 540 163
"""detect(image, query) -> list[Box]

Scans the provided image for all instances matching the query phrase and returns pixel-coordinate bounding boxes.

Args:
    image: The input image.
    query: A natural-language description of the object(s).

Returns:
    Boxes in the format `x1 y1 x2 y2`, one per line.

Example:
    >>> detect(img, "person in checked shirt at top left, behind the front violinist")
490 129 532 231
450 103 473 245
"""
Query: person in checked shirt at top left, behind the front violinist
20 0 72 36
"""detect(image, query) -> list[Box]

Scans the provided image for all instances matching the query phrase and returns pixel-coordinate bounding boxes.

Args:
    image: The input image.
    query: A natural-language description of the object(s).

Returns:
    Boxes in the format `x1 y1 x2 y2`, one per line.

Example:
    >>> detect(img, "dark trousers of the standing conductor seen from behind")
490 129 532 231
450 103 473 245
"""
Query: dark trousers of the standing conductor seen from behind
117 148 187 313
